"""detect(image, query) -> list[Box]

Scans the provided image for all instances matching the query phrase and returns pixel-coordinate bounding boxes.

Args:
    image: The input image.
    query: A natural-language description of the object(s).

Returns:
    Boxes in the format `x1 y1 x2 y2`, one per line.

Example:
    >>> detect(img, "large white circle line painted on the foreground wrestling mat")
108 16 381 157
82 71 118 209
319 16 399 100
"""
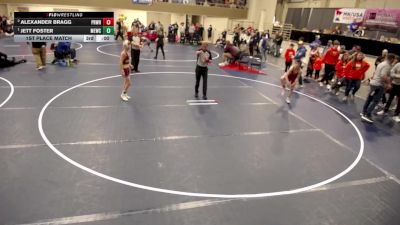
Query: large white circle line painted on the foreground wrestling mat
38 72 364 198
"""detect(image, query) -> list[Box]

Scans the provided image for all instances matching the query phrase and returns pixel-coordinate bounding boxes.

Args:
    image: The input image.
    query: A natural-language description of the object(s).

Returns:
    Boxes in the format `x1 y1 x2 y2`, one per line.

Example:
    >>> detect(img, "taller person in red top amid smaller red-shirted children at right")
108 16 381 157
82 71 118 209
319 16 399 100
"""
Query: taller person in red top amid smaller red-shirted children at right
320 40 340 89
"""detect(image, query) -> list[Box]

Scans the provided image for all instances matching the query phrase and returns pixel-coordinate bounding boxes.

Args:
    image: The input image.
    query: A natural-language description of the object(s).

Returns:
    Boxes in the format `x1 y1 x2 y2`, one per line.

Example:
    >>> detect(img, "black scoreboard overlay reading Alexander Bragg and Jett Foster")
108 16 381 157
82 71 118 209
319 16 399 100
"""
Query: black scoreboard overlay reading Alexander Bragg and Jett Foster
14 12 114 42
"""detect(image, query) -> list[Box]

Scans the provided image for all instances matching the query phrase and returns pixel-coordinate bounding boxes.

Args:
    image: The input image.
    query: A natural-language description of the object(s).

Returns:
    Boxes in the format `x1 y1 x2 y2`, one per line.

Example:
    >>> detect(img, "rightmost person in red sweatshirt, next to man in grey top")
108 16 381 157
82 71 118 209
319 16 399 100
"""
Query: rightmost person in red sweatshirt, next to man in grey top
343 52 369 101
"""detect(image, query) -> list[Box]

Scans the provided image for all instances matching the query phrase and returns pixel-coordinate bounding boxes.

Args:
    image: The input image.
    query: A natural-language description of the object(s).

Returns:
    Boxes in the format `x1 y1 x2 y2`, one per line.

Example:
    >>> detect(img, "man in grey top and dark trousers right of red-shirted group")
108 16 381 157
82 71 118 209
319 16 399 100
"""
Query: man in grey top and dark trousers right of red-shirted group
361 54 396 123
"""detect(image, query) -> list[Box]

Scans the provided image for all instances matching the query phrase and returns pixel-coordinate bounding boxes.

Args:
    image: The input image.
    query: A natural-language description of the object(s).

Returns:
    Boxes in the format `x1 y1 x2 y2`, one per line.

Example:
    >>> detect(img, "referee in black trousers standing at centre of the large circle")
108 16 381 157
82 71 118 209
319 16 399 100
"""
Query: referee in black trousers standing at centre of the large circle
194 42 212 100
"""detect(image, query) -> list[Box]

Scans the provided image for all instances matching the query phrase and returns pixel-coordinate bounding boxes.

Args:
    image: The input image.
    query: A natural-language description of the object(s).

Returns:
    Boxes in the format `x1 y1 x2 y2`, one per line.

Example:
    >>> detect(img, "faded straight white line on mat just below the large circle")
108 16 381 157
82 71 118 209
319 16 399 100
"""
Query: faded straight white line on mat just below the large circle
14 177 389 225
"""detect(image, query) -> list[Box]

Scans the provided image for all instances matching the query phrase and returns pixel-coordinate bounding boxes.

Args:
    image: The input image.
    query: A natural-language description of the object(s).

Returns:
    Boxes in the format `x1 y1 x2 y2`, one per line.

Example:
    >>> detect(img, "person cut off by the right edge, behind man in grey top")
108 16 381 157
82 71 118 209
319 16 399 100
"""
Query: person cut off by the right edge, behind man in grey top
377 56 400 123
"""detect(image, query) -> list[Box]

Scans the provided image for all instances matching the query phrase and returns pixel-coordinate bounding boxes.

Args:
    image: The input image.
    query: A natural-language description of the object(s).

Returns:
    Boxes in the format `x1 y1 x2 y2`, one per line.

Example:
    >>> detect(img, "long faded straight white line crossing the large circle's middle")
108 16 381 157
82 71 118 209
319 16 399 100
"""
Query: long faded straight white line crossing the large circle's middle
0 129 320 149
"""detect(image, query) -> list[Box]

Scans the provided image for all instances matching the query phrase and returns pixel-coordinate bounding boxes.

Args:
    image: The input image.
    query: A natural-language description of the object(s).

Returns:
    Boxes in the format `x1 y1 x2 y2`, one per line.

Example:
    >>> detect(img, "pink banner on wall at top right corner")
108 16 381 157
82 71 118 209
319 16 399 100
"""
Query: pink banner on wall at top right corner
363 9 400 32
